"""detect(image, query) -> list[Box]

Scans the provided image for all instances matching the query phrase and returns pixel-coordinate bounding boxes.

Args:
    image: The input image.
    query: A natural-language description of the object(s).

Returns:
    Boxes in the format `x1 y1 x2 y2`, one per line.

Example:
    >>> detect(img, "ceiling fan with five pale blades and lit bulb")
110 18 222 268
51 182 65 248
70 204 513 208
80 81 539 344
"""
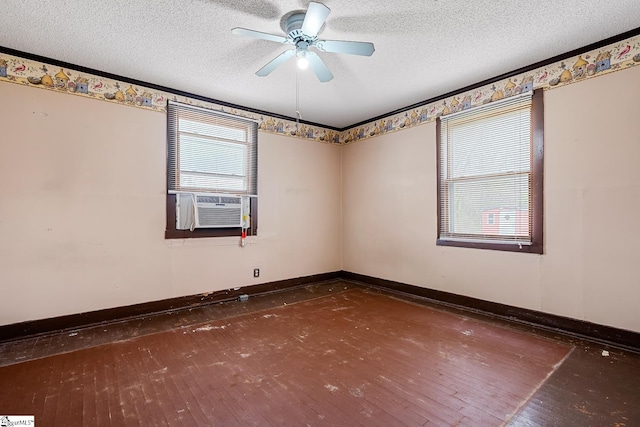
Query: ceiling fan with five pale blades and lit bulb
231 2 375 82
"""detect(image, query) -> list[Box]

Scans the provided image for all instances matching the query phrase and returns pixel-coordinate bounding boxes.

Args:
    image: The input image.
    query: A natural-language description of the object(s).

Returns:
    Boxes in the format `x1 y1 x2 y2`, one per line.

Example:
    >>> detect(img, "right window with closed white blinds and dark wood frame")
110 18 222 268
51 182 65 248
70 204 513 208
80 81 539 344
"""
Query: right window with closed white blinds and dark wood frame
436 90 544 254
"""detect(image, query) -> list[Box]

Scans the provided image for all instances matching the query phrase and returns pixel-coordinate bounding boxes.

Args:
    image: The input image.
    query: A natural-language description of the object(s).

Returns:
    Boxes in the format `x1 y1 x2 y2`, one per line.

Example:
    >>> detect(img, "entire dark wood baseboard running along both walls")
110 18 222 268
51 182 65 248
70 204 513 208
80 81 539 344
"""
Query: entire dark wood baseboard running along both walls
0 271 640 352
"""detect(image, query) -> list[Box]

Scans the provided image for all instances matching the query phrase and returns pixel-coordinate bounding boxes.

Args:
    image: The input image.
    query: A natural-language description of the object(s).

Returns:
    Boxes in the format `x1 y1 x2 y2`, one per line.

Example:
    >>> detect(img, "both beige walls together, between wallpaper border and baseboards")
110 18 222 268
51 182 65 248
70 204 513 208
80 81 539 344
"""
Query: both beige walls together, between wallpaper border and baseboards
0 63 640 331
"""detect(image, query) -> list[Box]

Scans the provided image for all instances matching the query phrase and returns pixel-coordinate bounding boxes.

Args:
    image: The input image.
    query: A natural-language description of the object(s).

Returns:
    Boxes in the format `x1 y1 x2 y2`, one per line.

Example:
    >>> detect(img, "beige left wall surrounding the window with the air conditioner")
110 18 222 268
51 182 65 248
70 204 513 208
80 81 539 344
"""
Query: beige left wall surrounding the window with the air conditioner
0 83 341 324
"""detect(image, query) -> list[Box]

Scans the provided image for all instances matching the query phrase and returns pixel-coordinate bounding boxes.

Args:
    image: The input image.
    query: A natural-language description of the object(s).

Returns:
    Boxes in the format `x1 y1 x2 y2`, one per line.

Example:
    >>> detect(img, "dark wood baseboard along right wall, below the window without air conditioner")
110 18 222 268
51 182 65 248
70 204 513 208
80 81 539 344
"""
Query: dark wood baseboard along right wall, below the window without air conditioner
341 271 640 352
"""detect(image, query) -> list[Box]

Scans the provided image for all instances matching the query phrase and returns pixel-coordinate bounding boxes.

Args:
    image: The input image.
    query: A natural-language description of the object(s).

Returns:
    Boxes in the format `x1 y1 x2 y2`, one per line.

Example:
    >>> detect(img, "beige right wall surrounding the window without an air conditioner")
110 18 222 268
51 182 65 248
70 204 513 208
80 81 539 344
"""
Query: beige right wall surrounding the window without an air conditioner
343 67 640 331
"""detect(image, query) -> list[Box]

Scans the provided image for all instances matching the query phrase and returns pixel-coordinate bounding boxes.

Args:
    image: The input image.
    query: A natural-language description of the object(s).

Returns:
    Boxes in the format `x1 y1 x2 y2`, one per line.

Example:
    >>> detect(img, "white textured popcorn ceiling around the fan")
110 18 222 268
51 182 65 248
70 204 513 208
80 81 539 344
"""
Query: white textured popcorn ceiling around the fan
0 0 640 128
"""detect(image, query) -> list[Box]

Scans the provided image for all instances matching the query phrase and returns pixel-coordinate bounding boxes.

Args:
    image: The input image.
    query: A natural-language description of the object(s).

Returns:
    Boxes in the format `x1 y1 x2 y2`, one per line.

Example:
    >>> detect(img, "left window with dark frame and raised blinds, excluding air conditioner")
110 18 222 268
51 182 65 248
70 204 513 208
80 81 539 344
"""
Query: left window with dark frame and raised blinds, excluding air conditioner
165 102 258 238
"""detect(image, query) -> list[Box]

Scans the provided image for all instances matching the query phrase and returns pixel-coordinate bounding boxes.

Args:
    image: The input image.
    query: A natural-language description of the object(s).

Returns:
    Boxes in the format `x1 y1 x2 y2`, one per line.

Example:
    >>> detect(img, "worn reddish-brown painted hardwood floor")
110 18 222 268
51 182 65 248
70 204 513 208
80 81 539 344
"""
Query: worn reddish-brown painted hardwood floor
0 281 640 426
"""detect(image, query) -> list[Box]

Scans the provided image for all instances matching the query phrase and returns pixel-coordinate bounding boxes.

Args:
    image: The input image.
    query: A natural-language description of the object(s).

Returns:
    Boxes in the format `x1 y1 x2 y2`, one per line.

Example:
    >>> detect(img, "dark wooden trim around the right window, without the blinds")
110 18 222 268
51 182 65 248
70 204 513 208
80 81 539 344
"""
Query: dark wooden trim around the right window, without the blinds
436 89 544 254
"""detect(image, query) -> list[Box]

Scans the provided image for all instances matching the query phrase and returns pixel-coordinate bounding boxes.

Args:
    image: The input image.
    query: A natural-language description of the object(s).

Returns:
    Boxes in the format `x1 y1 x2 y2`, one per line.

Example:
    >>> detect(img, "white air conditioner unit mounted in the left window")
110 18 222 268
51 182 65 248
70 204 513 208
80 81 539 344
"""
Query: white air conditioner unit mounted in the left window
176 193 249 230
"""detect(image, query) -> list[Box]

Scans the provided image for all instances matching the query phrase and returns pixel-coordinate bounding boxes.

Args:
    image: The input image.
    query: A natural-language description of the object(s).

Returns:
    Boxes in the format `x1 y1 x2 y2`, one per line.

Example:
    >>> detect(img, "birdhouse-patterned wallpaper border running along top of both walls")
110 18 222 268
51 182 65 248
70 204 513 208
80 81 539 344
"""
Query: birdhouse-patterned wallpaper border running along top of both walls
0 30 640 144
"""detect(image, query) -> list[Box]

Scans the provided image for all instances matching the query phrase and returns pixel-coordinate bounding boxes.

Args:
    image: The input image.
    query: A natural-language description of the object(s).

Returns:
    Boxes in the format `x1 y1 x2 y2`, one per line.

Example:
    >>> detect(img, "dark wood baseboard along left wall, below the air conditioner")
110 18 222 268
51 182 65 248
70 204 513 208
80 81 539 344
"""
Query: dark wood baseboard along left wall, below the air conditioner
0 271 340 342
